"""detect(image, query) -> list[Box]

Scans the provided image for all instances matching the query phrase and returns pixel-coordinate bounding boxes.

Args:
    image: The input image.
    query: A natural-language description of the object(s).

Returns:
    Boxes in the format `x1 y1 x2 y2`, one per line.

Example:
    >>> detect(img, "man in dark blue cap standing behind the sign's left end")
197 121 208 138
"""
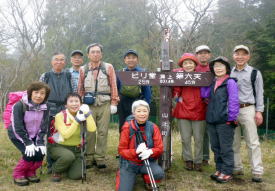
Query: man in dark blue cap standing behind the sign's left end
117 49 152 132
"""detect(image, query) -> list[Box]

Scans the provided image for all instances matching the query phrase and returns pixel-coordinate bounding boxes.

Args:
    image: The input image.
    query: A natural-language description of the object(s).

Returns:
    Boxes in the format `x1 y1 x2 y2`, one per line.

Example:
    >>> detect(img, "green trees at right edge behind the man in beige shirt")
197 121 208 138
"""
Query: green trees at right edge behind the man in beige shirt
197 0 275 129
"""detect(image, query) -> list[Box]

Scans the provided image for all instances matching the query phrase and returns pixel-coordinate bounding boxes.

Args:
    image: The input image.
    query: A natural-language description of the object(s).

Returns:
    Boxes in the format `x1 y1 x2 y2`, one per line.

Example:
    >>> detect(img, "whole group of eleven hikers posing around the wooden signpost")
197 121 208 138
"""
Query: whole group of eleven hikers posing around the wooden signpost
5 43 264 191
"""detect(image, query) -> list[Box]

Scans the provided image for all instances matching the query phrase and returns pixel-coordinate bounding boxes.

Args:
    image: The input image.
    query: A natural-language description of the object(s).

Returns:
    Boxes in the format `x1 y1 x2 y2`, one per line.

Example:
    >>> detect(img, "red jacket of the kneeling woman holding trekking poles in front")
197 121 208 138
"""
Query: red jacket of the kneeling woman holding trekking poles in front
118 121 163 163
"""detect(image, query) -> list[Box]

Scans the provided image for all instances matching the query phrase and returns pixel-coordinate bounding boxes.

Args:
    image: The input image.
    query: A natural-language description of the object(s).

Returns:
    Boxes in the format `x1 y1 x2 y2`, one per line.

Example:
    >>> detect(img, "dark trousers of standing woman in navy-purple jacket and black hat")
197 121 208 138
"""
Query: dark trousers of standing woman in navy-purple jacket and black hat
207 123 234 175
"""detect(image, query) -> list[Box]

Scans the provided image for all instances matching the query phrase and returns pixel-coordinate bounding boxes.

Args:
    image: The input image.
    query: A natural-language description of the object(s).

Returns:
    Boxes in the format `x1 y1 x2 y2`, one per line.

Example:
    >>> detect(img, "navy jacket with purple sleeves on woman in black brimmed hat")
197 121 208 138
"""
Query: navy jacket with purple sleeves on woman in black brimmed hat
201 78 240 124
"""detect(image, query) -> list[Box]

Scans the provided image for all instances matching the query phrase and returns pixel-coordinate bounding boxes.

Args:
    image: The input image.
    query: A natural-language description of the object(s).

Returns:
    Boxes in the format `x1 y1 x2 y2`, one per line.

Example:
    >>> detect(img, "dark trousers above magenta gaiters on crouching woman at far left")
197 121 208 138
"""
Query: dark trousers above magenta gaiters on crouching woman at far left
11 139 44 162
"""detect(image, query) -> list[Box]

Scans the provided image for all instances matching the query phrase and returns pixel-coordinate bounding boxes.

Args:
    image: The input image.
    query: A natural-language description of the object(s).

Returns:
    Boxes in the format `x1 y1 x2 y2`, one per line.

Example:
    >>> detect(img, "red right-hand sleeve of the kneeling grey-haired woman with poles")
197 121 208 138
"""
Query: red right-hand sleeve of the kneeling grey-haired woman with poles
150 124 163 159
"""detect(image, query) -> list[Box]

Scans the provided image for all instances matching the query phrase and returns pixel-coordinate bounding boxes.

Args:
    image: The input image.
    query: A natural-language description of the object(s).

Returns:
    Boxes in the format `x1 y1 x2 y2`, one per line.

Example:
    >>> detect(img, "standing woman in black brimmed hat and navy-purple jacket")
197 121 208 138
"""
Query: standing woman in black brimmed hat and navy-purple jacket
201 56 239 183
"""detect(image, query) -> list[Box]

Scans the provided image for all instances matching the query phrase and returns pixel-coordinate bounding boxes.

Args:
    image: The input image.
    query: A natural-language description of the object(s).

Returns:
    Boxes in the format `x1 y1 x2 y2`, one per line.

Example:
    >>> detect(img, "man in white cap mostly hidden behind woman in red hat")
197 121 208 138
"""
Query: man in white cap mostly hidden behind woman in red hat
196 45 212 166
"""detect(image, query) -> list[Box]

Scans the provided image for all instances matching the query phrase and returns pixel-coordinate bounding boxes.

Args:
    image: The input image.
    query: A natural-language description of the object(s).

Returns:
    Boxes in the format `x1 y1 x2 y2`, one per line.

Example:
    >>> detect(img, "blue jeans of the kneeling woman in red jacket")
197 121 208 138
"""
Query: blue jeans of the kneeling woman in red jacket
118 160 164 191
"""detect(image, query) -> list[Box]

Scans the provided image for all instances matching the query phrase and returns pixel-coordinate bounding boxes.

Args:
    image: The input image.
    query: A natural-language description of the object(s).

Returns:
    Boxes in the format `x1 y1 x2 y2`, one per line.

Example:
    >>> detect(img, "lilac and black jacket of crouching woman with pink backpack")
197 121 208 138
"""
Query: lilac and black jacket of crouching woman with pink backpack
8 95 49 146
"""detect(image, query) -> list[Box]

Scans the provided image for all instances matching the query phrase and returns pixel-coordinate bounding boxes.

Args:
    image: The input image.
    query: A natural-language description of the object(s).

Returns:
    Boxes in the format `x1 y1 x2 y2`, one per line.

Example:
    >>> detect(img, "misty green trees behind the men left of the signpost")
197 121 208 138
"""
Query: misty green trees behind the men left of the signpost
44 0 161 69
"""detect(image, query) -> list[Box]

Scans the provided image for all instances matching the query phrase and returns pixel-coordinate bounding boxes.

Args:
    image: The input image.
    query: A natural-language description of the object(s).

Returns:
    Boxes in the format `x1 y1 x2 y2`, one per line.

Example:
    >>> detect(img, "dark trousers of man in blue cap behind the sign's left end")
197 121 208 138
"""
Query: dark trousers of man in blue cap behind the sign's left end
118 95 138 133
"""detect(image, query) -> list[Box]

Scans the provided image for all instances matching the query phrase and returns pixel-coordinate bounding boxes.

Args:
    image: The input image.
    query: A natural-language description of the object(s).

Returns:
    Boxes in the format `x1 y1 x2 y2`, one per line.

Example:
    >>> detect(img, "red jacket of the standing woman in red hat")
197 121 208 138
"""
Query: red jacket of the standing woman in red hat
172 68 206 120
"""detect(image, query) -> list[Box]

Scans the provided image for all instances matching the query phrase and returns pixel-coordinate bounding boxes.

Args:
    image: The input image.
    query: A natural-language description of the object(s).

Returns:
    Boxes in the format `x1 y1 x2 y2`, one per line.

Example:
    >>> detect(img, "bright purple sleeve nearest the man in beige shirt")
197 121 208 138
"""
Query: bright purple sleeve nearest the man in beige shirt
227 79 240 121
